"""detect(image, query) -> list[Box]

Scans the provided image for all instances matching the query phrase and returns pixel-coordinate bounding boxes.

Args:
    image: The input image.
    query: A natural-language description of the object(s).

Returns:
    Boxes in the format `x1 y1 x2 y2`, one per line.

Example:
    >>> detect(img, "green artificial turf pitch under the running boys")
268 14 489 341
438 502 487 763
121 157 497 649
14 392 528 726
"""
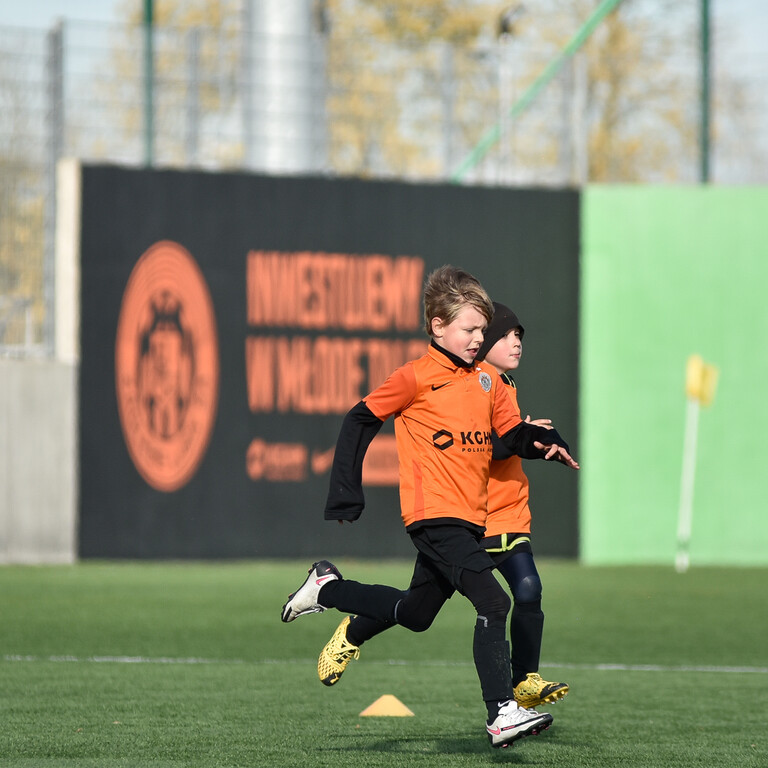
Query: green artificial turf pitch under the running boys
0 560 768 768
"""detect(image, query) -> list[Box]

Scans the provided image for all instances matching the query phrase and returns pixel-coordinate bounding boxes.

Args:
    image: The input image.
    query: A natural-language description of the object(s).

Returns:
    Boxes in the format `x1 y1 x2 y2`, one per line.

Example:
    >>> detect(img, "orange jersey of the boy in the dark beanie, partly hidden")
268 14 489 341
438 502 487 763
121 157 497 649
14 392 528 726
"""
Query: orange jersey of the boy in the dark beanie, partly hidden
485 384 531 537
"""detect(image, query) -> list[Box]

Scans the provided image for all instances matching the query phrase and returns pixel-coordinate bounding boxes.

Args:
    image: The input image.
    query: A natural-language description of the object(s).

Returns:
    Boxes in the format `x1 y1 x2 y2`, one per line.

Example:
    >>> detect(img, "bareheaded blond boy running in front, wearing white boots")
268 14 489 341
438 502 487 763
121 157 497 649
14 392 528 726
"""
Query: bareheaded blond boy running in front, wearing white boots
281 266 578 747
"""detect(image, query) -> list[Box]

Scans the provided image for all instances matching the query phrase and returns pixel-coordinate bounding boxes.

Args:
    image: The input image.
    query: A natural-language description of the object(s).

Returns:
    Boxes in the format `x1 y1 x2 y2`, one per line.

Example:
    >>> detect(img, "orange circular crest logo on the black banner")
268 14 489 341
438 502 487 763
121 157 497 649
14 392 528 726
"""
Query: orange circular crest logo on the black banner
115 240 219 492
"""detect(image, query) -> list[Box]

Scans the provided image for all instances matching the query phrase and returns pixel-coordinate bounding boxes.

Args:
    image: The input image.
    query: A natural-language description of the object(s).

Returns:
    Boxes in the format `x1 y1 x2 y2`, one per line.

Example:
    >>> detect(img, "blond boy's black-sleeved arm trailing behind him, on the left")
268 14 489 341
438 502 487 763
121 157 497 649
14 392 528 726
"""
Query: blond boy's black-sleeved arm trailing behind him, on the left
325 400 384 522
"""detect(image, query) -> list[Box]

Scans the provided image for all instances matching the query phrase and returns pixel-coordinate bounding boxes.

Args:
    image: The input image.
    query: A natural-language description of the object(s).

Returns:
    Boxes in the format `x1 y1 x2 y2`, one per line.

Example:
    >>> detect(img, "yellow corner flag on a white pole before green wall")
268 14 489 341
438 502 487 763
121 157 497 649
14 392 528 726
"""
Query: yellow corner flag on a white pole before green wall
675 355 718 573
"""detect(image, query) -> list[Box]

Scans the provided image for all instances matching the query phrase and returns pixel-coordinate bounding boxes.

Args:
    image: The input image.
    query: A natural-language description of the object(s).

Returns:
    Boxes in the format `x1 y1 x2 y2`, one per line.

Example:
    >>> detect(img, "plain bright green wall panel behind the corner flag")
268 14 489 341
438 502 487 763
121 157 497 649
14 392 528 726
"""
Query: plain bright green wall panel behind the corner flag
579 187 768 566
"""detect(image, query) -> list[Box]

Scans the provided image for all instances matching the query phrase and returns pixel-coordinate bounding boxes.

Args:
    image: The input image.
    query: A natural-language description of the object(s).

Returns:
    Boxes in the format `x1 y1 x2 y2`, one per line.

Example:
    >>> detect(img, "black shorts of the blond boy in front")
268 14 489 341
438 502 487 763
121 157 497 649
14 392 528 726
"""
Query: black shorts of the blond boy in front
409 524 494 597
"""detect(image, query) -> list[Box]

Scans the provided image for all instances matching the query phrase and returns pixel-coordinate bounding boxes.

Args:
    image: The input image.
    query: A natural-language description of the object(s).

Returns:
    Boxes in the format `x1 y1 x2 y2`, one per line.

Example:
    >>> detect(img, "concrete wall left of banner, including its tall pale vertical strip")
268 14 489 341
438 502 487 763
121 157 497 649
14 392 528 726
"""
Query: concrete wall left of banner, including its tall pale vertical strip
0 159 81 563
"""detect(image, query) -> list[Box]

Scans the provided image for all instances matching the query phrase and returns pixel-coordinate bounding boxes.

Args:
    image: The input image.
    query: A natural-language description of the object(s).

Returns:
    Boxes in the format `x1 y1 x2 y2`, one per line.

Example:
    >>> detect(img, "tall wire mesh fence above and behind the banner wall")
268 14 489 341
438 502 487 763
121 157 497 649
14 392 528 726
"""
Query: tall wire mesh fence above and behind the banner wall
0 12 768 355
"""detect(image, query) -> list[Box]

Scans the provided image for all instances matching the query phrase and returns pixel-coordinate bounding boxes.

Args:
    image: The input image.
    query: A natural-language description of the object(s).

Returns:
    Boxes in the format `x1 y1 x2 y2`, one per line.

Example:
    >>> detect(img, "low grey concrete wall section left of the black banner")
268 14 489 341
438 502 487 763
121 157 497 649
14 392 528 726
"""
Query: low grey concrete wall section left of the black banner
0 360 77 563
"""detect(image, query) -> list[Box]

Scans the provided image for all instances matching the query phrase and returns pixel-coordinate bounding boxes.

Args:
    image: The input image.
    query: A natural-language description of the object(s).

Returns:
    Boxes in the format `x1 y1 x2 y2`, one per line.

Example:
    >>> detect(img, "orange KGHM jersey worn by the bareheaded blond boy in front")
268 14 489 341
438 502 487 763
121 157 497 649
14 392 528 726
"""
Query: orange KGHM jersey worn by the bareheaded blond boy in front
364 346 521 526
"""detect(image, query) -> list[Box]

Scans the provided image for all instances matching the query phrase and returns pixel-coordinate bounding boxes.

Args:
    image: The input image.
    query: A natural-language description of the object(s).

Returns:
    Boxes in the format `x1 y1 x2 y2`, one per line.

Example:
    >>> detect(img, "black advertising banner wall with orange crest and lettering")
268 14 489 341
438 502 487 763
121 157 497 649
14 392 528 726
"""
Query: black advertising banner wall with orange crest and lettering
79 166 579 558
